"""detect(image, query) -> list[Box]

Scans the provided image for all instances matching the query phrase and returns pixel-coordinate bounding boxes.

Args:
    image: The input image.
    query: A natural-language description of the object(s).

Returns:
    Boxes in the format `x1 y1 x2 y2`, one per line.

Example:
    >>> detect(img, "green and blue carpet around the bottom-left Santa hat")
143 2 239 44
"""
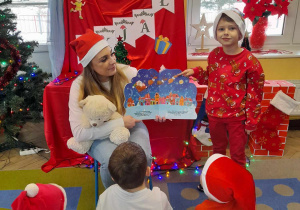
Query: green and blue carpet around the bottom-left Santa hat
0 168 104 210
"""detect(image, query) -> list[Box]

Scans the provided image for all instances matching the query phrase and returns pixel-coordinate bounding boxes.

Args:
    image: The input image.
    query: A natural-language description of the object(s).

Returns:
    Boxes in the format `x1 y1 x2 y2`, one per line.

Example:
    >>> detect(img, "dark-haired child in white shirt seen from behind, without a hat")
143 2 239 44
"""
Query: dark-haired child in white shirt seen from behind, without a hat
96 142 173 210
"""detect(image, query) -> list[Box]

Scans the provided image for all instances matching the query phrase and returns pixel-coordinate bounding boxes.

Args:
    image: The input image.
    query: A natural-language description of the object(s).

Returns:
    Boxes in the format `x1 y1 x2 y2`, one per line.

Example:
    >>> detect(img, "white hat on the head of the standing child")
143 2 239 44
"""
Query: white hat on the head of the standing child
213 8 246 40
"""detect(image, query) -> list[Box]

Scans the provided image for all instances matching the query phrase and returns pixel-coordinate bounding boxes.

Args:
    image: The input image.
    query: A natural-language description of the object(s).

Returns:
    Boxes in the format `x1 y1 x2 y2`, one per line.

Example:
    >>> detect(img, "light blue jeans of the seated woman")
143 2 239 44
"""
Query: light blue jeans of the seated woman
88 122 152 189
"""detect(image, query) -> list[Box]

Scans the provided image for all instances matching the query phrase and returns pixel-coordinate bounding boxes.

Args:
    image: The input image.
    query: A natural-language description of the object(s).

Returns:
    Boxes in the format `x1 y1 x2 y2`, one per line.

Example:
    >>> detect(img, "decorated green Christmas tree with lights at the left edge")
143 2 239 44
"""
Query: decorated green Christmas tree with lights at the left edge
0 0 51 152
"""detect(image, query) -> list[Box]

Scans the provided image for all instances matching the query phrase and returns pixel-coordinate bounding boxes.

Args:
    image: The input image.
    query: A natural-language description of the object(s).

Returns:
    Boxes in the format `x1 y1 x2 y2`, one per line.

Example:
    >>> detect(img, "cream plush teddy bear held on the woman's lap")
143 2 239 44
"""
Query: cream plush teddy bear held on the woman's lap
67 95 130 154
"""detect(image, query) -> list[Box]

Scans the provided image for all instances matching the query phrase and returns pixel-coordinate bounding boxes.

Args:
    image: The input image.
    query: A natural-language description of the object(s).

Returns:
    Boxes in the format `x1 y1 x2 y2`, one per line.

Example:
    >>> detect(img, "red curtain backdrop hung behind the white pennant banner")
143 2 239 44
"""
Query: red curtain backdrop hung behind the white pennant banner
61 0 187 75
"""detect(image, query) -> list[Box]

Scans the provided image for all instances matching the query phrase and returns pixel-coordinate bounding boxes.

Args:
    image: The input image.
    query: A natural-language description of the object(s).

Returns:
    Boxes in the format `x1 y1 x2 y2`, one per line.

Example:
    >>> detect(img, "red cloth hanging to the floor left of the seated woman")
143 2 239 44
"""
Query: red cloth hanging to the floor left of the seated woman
42 81 89 172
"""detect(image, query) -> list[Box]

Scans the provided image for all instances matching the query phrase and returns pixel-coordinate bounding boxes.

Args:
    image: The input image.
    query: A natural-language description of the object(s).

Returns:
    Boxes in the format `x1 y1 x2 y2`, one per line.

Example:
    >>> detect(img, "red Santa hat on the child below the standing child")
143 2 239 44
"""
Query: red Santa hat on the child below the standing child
197 154 256 210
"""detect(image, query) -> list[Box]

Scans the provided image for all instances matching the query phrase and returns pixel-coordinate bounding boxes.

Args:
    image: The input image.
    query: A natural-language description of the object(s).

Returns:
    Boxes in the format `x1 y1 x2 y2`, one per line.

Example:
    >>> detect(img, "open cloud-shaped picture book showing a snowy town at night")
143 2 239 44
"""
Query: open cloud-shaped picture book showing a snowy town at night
124 69 197 120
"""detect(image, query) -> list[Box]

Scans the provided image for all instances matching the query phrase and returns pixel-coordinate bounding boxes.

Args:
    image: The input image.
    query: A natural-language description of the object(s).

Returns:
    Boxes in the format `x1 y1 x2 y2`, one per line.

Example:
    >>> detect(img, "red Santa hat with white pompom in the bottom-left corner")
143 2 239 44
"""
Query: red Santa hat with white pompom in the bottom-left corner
11 184 67 210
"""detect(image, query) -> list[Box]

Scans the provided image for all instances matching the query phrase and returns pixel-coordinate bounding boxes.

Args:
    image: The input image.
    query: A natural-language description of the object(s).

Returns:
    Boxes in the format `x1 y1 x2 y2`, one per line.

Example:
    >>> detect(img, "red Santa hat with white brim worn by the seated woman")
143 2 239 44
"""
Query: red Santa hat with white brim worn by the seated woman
70 29 108 67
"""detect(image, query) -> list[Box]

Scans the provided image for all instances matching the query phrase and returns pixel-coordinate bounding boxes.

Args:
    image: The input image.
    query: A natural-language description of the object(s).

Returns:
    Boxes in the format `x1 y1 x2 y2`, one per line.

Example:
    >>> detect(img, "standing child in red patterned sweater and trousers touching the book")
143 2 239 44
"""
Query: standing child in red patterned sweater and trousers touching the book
180 9 265 167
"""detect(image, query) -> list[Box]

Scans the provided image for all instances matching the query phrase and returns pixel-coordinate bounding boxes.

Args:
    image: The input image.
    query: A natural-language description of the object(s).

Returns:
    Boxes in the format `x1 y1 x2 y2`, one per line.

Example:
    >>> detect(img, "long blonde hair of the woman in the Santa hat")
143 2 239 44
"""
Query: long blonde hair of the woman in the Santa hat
78 63 129 115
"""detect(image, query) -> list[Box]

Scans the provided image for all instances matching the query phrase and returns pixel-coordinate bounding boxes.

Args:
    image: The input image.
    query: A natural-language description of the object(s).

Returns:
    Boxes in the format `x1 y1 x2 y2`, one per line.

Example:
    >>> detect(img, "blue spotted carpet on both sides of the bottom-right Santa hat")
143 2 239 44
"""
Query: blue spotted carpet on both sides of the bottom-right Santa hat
167 178 300 210
